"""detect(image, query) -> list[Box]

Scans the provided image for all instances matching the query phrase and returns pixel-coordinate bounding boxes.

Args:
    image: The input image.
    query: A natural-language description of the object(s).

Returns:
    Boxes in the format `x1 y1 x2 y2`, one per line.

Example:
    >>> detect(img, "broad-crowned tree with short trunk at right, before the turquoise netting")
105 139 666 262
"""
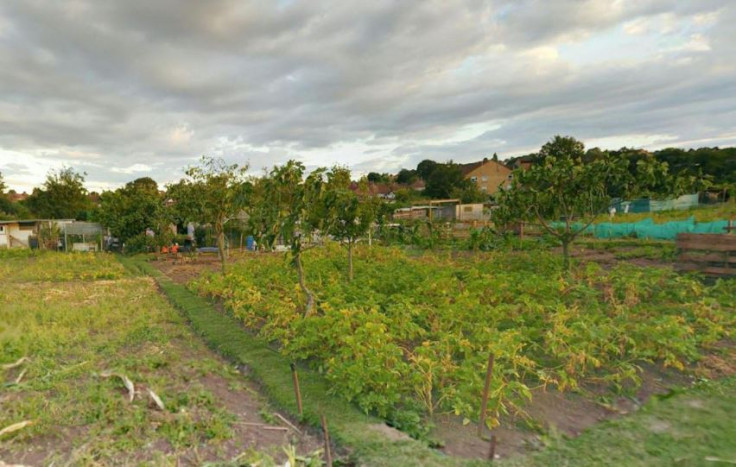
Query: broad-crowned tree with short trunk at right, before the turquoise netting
494 136 628 271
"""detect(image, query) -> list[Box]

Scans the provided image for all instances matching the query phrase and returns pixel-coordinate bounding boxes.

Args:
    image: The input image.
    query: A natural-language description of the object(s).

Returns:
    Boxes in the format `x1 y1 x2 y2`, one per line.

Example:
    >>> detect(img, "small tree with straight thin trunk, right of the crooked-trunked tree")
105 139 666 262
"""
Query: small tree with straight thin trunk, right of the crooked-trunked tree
324 168 376 282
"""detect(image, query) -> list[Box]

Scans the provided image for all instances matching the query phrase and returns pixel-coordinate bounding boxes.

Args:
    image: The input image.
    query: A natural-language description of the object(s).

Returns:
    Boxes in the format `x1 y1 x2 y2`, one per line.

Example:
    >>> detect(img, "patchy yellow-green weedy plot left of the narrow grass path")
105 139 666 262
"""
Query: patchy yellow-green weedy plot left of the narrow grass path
0 253 286 465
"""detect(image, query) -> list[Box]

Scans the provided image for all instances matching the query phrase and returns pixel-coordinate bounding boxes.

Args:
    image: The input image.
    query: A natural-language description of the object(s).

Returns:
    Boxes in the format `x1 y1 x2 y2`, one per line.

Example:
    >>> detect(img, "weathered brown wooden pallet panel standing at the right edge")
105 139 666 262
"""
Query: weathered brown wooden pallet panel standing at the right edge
676 233 736 277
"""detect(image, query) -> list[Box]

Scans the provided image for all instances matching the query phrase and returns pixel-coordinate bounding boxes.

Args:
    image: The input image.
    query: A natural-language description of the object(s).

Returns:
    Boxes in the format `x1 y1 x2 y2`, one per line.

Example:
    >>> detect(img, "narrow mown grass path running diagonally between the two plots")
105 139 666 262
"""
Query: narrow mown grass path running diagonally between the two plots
120 258 461 466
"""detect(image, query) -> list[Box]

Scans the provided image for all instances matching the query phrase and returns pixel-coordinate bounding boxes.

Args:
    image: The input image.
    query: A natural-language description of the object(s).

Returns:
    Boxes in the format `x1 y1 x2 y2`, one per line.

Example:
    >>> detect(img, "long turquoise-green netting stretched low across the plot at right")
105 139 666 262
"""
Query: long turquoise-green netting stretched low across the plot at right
552 217 728 240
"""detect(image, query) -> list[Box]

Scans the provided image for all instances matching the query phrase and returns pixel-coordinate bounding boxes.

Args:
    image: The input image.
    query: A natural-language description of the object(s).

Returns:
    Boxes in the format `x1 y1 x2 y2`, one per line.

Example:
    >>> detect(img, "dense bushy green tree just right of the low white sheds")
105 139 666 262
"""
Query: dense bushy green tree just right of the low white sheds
94 177 164 242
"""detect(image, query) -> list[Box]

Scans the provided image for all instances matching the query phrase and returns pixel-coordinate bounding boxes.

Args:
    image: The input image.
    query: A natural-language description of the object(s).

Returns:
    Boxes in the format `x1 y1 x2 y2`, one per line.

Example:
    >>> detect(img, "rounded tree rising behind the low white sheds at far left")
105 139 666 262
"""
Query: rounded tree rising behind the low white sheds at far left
25 167 92 220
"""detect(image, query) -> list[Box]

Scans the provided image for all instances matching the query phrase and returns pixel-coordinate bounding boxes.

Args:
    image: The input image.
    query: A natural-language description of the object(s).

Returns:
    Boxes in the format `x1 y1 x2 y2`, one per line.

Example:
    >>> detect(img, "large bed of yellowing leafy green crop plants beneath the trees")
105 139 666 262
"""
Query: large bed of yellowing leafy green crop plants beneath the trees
193 247 736 434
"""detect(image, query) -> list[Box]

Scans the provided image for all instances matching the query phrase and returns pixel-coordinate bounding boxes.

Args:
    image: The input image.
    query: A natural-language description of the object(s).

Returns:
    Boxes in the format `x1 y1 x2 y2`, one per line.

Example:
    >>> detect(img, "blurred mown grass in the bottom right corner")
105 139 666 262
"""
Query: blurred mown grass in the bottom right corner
503 377 736 466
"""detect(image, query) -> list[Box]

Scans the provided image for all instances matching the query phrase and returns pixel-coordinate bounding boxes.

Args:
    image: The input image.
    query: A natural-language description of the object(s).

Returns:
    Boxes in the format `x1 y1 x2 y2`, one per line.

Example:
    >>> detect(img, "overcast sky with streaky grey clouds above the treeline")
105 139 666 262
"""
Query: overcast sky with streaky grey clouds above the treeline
0 0 736 191
